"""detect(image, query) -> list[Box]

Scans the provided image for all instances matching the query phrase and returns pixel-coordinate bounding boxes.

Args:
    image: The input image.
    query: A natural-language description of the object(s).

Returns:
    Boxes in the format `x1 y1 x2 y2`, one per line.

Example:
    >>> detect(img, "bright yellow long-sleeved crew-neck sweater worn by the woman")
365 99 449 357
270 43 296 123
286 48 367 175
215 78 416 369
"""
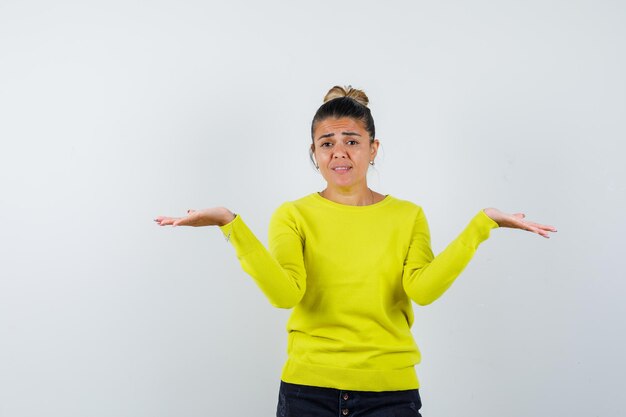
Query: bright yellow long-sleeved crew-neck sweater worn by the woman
221 193 498 391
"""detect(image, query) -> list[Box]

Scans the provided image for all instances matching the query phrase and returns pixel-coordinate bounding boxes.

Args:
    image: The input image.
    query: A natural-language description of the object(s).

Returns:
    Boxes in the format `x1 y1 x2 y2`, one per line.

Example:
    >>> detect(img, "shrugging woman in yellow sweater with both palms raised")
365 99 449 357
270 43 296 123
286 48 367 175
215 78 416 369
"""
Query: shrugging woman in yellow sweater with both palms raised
155 86 556 417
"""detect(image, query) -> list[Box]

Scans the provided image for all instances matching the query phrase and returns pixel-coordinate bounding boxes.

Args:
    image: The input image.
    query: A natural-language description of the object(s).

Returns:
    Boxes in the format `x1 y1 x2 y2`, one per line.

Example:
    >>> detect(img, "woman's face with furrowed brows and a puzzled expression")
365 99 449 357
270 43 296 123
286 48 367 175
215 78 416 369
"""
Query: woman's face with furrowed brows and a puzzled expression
313 117 378 190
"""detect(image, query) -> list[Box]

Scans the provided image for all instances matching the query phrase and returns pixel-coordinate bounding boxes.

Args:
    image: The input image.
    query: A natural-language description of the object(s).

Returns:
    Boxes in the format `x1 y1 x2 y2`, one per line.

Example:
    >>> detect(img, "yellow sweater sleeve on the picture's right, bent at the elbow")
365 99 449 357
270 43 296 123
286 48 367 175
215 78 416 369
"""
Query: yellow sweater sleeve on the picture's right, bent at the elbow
402 210 498 305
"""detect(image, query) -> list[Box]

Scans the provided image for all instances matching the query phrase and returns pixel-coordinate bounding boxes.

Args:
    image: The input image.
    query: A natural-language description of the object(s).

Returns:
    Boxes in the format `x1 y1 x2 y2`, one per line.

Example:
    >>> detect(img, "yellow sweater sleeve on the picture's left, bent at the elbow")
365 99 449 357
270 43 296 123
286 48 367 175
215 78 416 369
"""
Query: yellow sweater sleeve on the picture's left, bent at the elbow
220 205 306 308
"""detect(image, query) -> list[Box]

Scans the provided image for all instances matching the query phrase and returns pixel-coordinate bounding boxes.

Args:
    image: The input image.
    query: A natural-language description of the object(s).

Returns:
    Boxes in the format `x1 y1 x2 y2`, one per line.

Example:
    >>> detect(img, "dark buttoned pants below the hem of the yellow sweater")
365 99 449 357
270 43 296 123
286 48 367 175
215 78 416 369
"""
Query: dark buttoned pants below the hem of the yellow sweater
276 381 422 417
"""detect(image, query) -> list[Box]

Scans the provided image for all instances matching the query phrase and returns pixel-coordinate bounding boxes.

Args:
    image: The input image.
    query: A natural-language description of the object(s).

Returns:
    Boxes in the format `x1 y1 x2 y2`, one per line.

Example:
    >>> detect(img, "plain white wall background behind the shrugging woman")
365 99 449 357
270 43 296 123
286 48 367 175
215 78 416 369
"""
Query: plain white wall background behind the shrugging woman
0 0 626 417
